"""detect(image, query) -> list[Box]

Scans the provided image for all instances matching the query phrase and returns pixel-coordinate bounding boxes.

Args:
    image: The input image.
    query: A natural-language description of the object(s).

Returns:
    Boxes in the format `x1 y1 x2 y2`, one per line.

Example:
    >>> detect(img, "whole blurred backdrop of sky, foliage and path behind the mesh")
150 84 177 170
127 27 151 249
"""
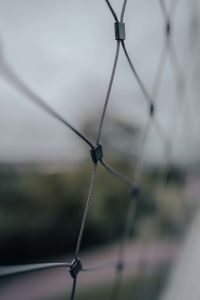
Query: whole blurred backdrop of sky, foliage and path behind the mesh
0 0 200 300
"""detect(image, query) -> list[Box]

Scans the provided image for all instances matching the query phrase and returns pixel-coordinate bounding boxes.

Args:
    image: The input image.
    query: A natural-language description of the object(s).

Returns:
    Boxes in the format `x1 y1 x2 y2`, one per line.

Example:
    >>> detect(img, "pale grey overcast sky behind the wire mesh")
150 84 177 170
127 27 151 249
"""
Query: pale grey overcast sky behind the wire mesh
0 0 199 166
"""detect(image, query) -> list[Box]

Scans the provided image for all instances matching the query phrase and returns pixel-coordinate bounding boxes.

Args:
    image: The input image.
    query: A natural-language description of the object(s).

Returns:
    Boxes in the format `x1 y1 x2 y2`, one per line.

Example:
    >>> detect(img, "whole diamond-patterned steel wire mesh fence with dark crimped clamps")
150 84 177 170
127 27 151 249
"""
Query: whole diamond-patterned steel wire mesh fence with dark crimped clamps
0 0 198 300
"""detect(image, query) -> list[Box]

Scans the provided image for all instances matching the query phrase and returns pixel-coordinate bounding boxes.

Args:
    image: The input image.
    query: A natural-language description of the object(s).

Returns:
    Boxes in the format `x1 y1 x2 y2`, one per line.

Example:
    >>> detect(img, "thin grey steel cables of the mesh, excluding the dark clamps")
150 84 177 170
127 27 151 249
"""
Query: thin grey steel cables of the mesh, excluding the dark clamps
0 0 198 300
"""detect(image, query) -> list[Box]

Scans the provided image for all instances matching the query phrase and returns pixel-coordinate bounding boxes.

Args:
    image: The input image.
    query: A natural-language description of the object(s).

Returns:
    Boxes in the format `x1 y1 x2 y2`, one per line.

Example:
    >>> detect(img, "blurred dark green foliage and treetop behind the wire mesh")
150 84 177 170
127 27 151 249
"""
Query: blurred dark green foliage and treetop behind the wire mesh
0 119 188 264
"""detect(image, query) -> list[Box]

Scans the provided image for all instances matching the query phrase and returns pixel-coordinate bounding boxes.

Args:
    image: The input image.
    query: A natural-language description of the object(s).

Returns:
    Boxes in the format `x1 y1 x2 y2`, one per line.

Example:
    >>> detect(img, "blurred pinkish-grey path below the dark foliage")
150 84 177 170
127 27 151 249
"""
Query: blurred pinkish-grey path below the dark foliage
0 242 180 300
